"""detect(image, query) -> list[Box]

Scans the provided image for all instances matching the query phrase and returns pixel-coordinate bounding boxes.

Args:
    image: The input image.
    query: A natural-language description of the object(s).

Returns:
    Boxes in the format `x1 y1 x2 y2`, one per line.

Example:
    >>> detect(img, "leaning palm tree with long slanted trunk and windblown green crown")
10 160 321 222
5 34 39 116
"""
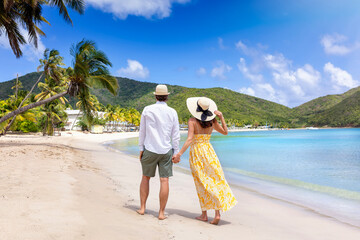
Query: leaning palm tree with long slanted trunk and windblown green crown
0 40 119 129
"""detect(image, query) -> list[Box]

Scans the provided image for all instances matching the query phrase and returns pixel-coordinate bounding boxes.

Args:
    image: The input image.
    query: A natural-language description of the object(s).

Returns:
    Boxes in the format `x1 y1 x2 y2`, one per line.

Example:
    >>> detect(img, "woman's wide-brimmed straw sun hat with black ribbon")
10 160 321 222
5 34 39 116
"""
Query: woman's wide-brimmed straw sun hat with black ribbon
186 97 217 121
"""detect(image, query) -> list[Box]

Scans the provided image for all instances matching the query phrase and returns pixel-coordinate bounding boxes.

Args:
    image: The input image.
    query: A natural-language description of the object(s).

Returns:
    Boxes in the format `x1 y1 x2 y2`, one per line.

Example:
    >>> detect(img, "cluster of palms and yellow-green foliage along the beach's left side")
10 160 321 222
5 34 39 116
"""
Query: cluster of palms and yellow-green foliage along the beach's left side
0 40 136 134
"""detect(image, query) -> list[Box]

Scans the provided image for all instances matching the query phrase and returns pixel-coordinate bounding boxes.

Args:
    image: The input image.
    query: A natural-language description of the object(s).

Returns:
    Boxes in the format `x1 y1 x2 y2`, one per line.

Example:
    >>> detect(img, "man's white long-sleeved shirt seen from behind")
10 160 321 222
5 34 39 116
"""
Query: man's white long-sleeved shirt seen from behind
139 101 180 154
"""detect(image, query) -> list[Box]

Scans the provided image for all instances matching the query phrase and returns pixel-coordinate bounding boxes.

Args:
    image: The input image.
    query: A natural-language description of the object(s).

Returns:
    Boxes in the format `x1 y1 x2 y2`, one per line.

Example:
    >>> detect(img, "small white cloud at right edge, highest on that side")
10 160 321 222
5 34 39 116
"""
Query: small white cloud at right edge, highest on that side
320 34 360 55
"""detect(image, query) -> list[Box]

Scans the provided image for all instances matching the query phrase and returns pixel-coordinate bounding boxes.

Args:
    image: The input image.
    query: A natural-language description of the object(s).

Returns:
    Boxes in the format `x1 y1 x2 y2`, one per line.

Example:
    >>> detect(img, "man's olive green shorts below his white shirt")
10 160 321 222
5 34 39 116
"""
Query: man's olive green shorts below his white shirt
141 149 173 178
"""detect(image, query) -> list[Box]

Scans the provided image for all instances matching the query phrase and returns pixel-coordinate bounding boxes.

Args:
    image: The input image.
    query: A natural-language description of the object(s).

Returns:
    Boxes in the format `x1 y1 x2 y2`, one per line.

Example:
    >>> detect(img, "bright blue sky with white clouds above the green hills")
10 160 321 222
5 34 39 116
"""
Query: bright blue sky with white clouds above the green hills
0 0 360 107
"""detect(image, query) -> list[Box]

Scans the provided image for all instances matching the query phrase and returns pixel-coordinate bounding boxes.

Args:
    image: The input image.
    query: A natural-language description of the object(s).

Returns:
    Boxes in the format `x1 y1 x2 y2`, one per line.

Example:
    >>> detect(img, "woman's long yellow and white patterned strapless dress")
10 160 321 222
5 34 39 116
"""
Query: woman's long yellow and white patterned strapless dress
189 134 237 212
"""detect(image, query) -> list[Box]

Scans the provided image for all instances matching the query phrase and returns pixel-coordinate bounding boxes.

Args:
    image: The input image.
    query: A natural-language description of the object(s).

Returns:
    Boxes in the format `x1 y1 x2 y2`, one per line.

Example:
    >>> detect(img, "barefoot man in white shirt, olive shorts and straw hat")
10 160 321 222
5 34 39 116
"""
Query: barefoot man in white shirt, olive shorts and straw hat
137 85 180 220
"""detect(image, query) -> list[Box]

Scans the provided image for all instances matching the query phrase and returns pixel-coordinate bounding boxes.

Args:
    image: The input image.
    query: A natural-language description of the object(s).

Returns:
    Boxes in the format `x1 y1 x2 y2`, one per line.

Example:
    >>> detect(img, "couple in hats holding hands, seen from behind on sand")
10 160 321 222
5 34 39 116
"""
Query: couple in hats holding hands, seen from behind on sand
137 85 237 224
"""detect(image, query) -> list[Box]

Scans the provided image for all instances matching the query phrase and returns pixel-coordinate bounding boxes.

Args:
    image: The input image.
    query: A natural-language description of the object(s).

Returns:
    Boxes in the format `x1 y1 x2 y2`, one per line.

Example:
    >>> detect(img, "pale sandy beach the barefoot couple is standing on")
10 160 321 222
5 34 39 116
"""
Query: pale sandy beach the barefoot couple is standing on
0 132 360 240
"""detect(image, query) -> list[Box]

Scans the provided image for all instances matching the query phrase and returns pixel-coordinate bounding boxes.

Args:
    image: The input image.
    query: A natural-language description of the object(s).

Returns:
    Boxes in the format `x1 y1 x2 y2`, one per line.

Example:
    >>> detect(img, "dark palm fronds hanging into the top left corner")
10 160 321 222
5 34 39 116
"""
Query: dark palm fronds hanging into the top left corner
0 0 85 57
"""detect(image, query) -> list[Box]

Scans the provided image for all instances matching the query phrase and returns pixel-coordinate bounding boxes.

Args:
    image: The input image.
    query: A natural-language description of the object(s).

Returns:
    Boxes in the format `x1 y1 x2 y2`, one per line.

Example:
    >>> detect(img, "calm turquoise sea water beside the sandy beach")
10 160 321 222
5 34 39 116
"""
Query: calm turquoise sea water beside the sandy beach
111 128 360 227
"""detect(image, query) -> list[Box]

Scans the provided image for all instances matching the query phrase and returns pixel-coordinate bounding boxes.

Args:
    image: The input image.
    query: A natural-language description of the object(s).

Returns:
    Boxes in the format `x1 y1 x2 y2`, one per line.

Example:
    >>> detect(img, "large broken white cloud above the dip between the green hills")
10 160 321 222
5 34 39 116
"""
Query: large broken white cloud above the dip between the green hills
235 41 321 106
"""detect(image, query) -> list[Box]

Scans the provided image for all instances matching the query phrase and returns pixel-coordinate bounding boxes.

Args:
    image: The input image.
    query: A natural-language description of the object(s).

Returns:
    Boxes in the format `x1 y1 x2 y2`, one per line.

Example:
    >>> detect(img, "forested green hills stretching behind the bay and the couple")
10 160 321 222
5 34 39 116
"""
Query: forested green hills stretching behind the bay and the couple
0 73 360 126
